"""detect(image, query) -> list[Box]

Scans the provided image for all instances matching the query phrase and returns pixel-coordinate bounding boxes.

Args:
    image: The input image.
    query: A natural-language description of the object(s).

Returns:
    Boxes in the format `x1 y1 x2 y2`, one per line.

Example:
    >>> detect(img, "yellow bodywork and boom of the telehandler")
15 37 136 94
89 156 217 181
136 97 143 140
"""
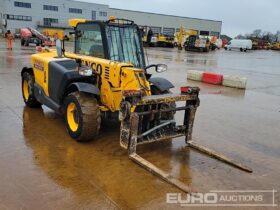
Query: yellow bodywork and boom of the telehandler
31 50 151 112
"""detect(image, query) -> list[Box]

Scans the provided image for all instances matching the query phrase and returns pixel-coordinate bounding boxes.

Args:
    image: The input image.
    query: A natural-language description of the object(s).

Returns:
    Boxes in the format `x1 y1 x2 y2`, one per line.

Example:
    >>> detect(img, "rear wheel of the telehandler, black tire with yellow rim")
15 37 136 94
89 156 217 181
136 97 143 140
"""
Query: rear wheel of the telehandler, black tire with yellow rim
21 72 41 108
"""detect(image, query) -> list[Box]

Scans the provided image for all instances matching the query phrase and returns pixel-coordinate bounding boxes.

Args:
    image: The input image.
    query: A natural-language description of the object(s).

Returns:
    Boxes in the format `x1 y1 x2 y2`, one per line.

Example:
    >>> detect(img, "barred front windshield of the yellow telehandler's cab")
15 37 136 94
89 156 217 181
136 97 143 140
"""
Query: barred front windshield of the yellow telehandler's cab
106 25 145 69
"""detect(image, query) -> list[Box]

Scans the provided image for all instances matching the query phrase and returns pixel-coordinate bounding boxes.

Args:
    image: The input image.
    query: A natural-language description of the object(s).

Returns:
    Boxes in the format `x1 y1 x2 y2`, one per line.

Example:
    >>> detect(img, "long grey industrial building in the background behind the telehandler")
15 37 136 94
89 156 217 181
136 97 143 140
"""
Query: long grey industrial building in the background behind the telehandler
0 0 222 36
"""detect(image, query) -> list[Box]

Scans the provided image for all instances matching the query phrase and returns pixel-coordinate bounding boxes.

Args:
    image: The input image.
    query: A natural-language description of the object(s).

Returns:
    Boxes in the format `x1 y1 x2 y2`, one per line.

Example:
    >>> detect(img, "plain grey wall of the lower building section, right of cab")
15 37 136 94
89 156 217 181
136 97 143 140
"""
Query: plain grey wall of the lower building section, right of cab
109 8 222 34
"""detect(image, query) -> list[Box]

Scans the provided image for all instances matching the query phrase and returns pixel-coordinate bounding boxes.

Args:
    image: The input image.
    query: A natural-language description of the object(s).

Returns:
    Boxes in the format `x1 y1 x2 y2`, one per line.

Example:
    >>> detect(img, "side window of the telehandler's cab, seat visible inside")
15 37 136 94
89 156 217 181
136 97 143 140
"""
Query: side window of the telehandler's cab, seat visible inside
75 23 105 58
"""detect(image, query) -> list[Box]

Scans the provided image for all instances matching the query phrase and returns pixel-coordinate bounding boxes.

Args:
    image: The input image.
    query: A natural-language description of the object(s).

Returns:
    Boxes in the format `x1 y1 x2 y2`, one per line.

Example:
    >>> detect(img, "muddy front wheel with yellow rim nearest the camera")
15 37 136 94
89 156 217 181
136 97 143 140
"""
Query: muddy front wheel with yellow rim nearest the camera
63 92 101 142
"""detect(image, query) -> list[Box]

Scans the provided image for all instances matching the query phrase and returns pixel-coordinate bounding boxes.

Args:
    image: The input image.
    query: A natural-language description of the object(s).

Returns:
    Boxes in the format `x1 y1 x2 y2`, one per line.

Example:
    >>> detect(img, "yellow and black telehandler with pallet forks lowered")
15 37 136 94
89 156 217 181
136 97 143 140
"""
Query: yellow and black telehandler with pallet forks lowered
21 18 251 192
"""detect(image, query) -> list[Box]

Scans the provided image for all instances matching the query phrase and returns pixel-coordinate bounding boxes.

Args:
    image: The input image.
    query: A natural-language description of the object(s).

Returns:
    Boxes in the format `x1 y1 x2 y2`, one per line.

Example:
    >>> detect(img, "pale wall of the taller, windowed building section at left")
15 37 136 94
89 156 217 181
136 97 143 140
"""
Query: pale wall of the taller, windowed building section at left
0 0 109 32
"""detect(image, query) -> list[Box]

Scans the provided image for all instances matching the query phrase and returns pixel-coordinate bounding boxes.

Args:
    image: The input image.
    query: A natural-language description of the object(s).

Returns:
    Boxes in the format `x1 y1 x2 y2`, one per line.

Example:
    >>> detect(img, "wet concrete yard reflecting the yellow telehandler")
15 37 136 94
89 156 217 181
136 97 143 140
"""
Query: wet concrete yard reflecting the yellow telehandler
0 41 280 209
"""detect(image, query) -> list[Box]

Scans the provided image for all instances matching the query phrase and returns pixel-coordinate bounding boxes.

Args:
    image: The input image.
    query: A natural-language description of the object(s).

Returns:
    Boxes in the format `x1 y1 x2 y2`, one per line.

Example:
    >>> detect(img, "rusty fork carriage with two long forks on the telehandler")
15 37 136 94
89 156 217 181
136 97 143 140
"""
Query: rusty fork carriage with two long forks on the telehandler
119 87 252 193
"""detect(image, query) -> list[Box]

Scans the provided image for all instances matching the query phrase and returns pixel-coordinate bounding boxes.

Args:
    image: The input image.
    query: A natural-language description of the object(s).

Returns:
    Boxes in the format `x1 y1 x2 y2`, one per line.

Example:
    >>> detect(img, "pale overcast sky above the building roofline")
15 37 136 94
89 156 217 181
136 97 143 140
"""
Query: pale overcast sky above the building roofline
77 0 280 36
